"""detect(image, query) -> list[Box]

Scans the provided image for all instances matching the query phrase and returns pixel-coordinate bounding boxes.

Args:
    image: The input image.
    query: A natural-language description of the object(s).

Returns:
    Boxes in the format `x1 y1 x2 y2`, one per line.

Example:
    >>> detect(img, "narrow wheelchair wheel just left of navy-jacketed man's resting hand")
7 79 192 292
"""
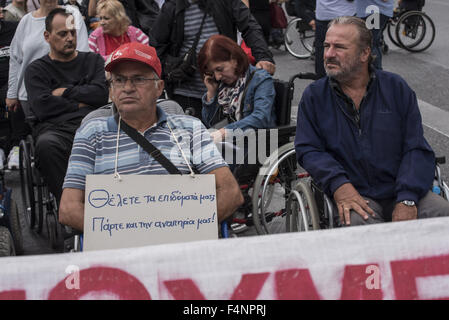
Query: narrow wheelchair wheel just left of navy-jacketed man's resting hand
286 179 320 232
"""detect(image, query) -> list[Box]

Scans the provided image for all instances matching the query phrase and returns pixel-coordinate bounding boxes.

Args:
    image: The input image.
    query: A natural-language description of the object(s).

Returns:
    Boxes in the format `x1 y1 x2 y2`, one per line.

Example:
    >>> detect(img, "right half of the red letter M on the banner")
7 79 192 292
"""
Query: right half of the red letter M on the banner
340 264 382 300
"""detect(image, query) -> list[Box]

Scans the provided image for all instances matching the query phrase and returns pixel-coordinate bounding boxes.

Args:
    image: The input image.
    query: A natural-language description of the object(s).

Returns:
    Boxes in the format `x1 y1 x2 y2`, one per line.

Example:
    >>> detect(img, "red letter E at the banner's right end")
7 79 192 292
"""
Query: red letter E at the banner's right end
391 255 449 300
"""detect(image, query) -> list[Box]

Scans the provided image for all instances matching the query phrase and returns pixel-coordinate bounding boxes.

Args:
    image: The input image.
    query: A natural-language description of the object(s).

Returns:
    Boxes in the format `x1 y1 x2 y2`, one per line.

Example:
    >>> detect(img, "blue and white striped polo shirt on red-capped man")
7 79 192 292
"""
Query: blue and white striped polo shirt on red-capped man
63 107 227 190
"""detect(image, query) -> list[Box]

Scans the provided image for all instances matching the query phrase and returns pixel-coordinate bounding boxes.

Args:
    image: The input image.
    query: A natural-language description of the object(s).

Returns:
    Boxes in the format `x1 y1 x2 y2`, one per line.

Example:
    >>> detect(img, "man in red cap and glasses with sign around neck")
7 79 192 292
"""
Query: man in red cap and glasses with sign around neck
59 42 243 230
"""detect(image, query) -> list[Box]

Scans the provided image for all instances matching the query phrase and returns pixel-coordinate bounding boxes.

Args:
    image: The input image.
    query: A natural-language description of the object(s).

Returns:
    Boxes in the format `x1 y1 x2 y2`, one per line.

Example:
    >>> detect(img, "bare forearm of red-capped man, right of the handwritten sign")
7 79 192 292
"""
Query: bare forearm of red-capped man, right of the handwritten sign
210 167 244 222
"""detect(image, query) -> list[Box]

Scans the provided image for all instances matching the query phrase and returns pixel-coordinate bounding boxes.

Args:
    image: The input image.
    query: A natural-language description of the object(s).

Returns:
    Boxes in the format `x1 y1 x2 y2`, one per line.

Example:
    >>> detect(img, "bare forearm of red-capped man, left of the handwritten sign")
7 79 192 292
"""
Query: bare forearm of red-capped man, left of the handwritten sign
59 188 84 231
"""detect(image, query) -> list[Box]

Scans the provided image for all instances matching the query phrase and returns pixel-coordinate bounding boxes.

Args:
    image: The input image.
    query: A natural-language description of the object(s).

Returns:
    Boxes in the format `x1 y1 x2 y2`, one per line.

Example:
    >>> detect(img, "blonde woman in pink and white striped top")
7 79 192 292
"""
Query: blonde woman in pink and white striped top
89 0 149 60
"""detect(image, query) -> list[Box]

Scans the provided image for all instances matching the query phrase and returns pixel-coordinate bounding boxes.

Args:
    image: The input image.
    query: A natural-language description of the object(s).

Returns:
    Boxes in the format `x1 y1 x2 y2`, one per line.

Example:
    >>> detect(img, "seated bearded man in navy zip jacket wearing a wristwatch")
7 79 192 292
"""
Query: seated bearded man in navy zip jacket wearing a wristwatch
295 17 449 225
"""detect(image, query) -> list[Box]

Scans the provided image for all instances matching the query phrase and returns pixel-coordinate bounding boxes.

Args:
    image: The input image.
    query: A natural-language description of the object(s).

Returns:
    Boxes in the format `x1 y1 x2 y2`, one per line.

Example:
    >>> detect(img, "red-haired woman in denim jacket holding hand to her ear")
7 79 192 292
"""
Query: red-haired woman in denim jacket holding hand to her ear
198 35 276 142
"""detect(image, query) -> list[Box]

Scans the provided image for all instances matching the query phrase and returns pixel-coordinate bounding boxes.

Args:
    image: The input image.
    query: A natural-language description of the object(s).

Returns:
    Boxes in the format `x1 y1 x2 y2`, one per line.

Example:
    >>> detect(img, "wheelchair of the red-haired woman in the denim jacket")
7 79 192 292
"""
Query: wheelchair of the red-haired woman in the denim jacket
221 73 316 237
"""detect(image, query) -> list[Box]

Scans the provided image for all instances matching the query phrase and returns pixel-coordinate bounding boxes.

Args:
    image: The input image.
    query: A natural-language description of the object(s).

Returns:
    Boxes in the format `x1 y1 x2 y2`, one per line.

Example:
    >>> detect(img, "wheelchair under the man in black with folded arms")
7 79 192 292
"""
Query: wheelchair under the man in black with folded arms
19 116 62 249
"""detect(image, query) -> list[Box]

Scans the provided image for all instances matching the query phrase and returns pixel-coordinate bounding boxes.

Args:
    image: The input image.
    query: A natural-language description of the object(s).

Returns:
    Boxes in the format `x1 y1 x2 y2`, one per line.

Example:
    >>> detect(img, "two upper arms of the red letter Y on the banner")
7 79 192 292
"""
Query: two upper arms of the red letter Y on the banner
164 272 270 300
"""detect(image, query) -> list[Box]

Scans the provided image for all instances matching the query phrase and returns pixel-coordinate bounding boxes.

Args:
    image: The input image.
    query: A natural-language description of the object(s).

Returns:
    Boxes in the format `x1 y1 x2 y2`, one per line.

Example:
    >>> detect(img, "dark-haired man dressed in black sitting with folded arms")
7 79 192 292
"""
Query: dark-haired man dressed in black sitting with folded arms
25 8 108 203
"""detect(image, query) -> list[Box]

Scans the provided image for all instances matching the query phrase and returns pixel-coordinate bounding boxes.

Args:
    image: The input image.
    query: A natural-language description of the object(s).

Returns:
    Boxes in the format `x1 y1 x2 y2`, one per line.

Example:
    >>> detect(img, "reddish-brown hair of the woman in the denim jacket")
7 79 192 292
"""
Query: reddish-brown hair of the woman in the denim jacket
198 34 249 77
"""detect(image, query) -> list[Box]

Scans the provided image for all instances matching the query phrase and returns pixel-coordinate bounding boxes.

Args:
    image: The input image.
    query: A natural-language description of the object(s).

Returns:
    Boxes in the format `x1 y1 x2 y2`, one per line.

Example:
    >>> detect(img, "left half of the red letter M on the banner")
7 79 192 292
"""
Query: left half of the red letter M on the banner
275 269 321 300
